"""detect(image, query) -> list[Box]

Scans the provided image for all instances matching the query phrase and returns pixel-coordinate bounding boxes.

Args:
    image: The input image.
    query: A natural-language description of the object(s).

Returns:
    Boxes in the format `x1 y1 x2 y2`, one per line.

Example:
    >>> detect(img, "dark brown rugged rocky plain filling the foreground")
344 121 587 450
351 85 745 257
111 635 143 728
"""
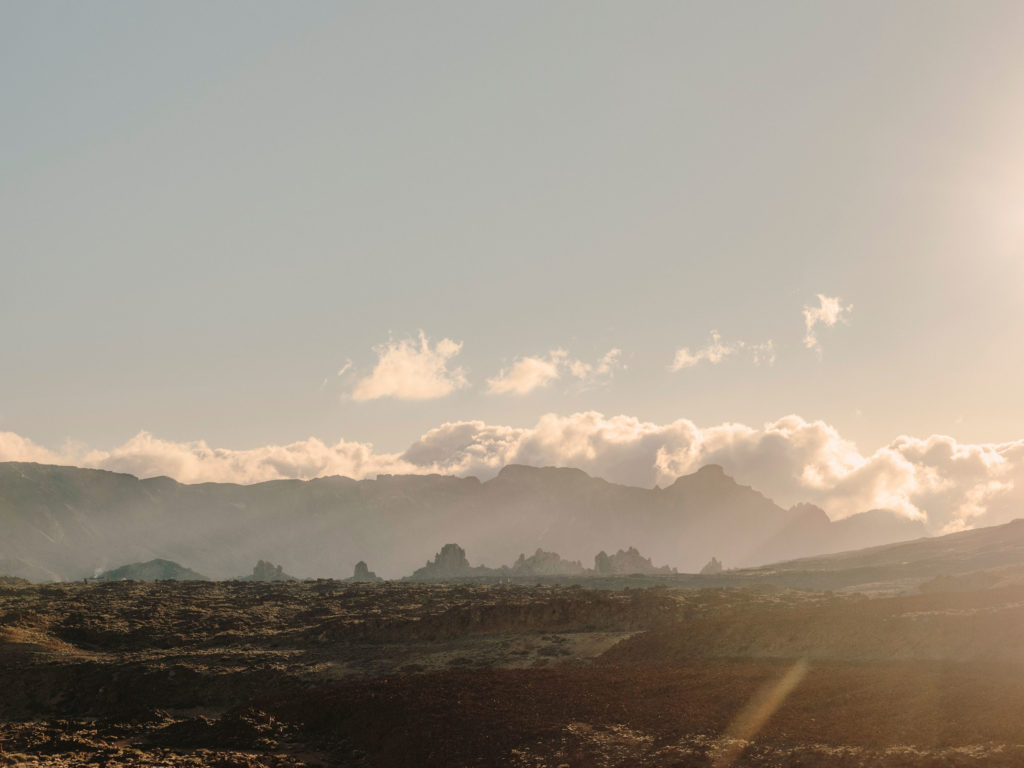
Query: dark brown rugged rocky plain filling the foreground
6 581 1024 768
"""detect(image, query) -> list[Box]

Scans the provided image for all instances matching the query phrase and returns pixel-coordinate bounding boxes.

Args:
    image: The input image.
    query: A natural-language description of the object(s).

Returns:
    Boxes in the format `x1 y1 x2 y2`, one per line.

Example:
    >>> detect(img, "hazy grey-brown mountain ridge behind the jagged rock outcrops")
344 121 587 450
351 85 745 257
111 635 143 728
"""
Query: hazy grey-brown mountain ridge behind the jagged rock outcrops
0 462 925 581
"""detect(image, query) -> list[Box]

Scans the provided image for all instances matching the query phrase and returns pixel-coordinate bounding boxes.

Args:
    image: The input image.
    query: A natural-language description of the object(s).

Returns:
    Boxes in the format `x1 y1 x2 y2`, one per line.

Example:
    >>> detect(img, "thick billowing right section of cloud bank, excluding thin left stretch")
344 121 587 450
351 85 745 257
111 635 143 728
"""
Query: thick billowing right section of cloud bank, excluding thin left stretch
401 412 1024 531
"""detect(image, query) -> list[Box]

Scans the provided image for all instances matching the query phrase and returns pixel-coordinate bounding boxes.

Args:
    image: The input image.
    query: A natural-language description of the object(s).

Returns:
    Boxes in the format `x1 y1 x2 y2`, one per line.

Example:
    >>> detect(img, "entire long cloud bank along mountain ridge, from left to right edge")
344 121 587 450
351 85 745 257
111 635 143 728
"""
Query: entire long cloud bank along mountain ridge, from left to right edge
0 412 1024 532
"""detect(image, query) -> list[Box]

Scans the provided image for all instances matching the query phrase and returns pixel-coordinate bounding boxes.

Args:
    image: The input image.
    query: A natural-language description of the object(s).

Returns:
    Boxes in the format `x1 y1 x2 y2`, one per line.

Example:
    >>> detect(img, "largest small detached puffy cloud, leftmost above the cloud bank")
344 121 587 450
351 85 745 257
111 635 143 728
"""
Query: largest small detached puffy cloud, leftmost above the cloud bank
350 331 467 400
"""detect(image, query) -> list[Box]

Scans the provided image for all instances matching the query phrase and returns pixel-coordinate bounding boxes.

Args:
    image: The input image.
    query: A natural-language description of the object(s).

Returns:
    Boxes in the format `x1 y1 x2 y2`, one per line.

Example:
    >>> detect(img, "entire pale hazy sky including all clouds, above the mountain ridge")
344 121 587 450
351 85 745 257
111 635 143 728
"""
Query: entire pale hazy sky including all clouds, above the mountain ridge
0 0 1024 529
